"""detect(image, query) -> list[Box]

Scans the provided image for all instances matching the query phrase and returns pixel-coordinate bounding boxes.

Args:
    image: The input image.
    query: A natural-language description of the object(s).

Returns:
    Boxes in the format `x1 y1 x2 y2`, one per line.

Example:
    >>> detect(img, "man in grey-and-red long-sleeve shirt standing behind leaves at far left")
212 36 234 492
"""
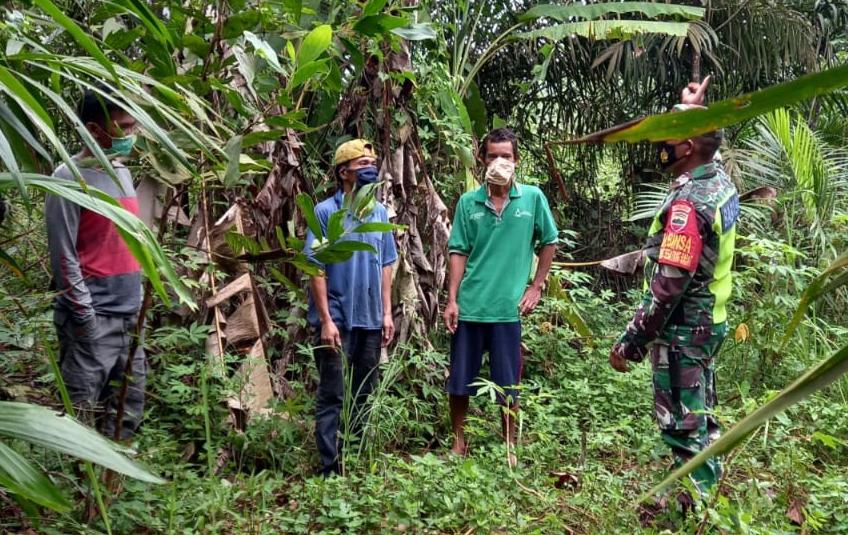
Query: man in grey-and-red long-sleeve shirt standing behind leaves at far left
44 91 146 439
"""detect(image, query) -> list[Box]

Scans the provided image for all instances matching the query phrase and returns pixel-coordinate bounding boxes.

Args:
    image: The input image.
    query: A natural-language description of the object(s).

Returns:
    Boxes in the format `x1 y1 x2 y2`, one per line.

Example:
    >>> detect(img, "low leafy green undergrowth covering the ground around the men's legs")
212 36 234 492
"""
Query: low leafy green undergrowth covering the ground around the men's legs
0 240 848 534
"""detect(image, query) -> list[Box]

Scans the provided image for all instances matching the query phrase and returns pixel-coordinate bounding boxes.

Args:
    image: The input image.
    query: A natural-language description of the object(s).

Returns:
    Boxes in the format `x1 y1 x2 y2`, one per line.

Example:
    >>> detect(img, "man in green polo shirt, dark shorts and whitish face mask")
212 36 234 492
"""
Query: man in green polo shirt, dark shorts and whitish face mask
444 128 558 464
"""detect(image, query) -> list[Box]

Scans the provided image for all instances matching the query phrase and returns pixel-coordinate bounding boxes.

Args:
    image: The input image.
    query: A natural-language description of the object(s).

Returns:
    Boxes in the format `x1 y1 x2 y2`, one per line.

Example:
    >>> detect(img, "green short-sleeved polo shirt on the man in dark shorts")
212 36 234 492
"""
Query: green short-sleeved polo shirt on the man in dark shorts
448 183 558 323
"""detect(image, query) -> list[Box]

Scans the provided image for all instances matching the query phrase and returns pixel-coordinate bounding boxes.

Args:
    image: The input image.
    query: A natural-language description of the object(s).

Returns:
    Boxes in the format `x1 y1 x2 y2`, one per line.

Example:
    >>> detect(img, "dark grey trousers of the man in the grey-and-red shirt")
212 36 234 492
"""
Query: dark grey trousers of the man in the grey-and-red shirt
53 310 147 440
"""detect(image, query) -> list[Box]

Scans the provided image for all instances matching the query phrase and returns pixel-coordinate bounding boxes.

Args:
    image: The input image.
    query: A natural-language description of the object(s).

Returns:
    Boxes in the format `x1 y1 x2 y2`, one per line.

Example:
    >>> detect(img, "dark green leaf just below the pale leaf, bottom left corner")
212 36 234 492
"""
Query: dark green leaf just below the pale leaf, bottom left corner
0 442 71 513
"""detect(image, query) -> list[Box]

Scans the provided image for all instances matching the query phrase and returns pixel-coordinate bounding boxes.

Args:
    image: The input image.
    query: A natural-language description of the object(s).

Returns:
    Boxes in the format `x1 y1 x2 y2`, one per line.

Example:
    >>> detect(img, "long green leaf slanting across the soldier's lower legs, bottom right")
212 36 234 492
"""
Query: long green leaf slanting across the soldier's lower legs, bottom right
639 346 848 501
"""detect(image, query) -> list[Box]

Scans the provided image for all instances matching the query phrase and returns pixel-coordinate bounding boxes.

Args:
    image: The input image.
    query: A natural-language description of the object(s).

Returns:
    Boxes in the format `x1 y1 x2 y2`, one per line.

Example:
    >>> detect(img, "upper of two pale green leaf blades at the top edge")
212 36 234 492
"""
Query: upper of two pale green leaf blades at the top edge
519 2 706 22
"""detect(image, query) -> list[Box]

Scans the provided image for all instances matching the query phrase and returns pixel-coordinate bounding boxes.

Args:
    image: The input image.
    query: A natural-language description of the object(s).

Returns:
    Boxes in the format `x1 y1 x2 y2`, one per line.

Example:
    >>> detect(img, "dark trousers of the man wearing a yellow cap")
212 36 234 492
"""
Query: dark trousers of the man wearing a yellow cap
314 328 382 475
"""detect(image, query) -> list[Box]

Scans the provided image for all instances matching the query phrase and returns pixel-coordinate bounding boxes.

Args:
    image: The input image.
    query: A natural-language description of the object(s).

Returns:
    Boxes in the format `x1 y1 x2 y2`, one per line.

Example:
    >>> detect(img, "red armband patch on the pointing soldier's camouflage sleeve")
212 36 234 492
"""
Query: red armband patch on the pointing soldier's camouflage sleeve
657 200 704 272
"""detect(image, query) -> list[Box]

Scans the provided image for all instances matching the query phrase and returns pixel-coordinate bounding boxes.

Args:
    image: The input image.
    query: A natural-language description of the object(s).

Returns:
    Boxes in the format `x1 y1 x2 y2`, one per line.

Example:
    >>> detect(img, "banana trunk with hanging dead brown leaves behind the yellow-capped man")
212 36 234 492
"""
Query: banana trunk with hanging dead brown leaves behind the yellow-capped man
339 17 450 344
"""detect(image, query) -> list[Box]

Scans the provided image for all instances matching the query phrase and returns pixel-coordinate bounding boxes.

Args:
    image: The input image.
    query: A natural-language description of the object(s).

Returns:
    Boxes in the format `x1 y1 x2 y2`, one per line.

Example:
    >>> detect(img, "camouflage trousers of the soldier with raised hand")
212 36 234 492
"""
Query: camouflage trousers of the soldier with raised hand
651 329 725 498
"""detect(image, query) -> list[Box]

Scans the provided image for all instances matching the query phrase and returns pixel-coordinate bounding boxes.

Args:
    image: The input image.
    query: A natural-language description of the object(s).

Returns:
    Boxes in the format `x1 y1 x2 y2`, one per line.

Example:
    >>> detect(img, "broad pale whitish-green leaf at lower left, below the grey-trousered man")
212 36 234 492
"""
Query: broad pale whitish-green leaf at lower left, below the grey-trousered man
0 401 165 483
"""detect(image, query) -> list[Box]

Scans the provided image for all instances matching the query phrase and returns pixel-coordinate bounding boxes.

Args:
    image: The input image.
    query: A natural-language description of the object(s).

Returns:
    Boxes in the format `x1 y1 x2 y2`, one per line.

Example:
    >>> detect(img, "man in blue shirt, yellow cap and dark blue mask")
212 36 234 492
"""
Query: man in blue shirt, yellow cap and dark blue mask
304 139 397 476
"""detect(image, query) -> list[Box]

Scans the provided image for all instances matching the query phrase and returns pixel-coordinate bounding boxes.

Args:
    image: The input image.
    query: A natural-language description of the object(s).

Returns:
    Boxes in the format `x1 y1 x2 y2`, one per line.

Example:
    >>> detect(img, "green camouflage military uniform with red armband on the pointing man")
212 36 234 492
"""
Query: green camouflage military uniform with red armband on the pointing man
620 163 739 490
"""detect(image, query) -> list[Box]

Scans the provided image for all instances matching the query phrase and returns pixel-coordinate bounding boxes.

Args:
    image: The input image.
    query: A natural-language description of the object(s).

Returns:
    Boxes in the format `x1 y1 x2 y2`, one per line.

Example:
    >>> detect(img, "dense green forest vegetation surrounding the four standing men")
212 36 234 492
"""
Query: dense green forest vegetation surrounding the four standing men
0 0 848 534
